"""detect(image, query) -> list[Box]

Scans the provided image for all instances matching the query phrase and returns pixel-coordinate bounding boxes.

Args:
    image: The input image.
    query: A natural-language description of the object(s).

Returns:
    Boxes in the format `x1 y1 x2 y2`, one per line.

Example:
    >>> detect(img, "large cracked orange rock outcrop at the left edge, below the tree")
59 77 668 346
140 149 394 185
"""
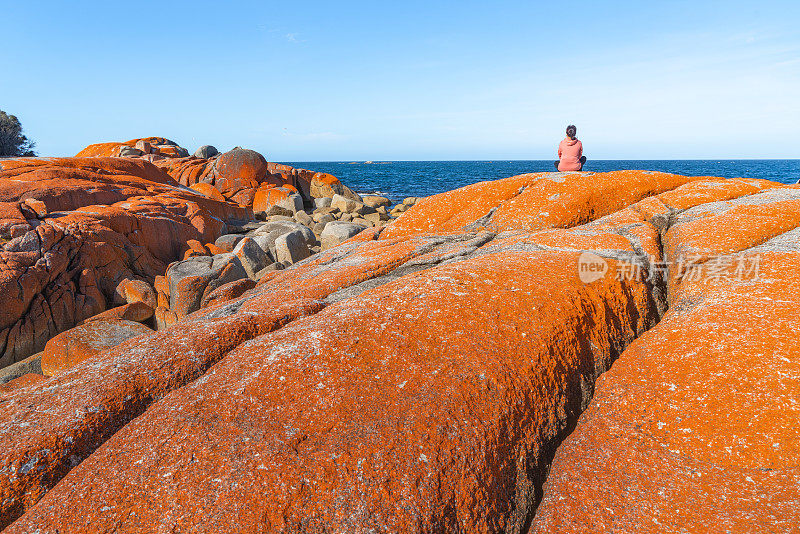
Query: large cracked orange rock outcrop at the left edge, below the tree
0 157 251 366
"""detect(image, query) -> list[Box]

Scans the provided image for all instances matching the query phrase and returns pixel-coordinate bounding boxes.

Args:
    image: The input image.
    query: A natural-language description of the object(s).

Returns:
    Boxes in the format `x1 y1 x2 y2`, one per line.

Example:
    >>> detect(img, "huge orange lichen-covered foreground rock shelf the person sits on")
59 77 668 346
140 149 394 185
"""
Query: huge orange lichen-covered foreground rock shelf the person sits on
0 169 800 533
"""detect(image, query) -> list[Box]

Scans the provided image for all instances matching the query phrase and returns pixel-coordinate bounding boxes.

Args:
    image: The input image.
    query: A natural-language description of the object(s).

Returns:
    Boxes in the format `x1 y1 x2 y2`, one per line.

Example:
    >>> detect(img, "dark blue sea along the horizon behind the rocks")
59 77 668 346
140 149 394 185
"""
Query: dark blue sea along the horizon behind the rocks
288 159 800 201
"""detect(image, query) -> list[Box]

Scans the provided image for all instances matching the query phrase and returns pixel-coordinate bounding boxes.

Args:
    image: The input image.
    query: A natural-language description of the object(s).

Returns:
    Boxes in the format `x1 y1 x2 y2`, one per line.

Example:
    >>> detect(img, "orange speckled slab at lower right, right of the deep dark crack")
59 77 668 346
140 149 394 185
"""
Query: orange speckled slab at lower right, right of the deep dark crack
532 244 800 532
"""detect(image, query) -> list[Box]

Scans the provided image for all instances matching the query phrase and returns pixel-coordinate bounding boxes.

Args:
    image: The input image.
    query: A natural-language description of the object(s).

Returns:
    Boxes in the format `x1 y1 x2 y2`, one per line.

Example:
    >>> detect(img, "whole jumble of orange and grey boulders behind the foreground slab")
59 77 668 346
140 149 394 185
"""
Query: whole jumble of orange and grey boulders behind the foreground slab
0 137 406 383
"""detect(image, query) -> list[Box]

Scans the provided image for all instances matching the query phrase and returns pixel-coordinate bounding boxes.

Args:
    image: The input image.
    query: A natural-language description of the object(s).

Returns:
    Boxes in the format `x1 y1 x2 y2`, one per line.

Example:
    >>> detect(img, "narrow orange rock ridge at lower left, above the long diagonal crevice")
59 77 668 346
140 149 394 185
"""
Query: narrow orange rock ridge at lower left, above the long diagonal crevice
0 300 323 530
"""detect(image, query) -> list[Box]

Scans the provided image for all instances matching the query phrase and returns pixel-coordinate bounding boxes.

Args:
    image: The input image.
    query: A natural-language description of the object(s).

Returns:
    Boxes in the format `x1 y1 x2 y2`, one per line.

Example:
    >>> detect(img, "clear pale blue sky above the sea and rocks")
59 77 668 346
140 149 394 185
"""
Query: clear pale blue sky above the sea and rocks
0 0 800 161
